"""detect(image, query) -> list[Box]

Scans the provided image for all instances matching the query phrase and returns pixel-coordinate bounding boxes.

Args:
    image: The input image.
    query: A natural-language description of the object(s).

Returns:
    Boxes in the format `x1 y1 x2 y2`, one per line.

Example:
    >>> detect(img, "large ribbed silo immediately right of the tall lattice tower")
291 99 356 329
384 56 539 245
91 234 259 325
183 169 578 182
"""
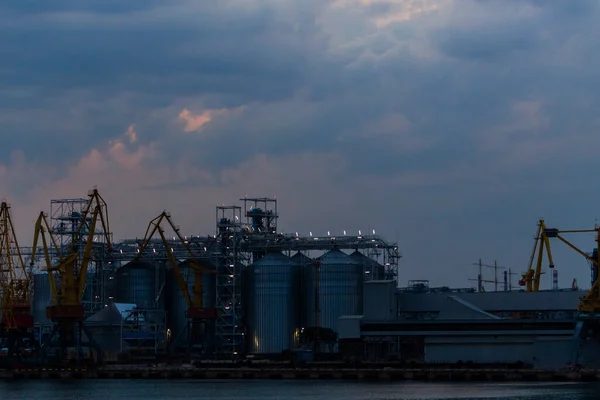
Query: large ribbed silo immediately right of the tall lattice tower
244 253 301 354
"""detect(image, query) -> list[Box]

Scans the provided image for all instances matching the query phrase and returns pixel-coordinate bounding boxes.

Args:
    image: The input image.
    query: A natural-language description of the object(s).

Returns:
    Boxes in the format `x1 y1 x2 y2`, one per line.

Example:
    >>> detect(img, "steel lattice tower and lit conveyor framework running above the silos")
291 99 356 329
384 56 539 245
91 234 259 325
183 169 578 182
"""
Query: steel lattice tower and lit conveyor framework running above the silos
23 197 402 357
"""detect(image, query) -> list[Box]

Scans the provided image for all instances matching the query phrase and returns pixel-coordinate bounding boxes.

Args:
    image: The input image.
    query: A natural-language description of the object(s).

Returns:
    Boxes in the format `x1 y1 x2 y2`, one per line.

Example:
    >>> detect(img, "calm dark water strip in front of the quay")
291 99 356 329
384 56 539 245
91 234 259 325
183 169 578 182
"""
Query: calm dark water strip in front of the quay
0 380 600 400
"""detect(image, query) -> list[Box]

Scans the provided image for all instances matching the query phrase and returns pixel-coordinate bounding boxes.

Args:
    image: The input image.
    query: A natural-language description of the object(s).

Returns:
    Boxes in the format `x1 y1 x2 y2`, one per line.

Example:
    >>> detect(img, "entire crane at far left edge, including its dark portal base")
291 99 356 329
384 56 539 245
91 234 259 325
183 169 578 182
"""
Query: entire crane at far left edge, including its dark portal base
0 201 34 361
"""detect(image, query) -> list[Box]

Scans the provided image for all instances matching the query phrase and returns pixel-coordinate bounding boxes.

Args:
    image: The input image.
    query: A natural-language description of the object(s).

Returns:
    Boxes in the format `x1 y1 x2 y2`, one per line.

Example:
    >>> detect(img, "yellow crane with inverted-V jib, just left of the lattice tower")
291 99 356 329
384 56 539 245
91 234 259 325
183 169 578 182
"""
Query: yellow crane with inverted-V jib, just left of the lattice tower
134 211 217 354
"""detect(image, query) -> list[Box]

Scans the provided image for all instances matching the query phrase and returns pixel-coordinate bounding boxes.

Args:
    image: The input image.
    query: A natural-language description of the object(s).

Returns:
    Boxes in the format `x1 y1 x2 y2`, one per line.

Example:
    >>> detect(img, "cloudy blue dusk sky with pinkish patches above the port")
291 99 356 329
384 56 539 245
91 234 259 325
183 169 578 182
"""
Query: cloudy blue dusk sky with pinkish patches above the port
0 0 600 290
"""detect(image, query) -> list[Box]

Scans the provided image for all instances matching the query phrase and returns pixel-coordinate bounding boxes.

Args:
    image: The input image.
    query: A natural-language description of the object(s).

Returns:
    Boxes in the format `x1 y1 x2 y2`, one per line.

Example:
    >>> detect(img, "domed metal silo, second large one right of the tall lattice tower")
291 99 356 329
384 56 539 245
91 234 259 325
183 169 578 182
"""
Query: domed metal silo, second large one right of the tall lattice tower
303 250 364 332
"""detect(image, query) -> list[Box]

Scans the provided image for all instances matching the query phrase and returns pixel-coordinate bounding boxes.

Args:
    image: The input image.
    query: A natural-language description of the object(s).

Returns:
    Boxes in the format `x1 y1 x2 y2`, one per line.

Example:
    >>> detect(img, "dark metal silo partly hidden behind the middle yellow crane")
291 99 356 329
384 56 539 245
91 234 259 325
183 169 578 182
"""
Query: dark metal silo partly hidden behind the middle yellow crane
167 260 217 346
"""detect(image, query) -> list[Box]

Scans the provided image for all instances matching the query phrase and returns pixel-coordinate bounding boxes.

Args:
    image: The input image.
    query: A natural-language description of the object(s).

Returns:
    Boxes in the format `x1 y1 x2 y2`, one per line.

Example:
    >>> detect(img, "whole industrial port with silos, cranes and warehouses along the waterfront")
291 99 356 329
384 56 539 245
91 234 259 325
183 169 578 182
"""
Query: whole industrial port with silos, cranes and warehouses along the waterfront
0 189 600 379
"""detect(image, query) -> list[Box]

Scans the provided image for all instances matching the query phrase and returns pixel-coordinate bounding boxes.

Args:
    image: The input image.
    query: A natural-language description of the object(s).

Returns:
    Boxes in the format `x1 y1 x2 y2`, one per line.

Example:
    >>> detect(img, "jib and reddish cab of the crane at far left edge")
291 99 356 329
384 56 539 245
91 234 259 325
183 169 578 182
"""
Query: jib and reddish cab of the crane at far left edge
0 201 33 331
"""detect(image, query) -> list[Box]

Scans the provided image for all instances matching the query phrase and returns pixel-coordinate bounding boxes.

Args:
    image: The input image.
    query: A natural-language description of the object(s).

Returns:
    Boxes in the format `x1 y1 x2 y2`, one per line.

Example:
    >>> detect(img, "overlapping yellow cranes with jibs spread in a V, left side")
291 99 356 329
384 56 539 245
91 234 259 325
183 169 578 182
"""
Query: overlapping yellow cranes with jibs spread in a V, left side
31 189 112 361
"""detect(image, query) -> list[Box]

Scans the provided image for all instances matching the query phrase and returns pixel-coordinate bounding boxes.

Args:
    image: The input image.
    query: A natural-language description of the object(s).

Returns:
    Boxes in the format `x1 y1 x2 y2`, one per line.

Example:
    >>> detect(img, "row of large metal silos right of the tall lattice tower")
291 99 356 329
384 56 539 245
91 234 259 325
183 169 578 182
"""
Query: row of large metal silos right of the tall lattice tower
243 250 383 354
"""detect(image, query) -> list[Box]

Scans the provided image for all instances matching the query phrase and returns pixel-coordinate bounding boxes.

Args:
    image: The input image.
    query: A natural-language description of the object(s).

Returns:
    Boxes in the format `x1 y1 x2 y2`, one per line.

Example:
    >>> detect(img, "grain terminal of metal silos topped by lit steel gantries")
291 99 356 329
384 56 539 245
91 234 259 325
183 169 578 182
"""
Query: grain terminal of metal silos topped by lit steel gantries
11 191 401 361
